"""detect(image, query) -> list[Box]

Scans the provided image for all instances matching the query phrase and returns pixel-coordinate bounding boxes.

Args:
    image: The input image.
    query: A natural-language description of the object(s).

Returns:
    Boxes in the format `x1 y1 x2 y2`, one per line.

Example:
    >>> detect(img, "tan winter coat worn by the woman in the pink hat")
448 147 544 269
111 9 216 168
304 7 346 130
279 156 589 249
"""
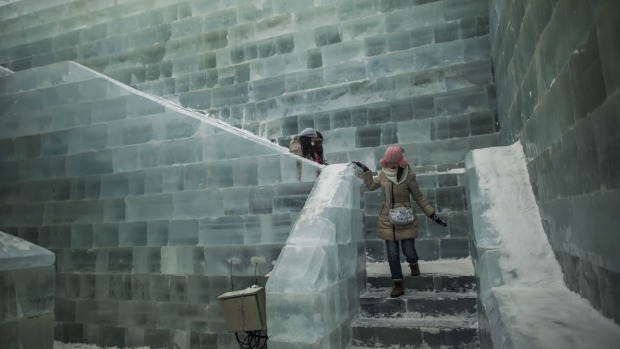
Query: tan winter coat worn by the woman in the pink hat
364 168 435 240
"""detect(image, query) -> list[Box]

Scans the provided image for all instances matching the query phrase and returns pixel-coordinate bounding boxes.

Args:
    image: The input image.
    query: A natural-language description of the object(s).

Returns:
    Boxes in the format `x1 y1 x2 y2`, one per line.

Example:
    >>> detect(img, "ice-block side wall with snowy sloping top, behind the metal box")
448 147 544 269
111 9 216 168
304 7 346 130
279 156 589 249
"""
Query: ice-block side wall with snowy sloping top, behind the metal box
0 62 319 348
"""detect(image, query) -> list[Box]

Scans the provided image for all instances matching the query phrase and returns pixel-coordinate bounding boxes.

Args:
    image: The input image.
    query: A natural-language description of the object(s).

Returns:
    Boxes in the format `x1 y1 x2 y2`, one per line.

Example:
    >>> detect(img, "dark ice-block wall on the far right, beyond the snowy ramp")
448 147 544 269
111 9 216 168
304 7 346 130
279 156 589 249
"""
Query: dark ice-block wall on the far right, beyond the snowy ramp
490 0 620 323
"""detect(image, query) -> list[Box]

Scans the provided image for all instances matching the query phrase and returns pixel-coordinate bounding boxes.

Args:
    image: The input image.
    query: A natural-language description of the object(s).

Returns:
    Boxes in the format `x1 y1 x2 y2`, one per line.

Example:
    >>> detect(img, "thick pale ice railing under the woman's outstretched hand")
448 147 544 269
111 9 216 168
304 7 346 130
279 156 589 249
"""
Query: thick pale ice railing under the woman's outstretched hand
266 164 366 349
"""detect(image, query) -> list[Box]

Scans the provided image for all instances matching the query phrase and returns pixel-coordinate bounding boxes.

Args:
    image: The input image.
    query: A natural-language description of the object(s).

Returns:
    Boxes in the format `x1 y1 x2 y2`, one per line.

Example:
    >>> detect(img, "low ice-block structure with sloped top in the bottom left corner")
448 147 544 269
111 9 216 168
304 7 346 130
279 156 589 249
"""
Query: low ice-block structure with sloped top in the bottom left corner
0 231 55 349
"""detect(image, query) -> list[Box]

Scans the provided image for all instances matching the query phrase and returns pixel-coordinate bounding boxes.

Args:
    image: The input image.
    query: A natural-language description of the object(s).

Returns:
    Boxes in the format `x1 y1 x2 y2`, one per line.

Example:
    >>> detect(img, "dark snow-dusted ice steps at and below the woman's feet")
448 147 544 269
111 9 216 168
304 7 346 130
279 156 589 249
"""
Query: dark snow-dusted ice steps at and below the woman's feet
350 258 478 349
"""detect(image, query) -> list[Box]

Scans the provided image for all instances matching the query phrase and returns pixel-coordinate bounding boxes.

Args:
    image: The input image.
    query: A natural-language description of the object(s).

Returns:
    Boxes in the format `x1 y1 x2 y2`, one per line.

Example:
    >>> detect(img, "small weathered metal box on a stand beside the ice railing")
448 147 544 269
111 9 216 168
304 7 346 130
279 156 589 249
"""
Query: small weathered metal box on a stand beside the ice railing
217 286 267 332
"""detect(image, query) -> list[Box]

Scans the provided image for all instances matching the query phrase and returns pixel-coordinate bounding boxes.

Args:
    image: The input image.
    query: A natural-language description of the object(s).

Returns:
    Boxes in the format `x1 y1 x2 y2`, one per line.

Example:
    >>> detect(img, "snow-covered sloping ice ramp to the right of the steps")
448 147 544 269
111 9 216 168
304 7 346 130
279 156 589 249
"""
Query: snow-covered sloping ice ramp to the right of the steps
466 142 620 349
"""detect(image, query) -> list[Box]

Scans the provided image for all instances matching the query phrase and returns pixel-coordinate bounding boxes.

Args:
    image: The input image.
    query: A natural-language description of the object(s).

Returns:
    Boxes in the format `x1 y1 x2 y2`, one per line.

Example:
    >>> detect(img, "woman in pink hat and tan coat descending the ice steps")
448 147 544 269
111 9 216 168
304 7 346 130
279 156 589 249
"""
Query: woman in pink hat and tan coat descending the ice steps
355 146 446 297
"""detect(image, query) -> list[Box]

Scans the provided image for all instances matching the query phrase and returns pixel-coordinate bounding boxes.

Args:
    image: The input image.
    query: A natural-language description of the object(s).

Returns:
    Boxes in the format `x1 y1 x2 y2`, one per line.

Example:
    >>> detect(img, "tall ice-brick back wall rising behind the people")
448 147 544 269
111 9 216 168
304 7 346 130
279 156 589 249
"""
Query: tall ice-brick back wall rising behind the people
0 0 499 167
